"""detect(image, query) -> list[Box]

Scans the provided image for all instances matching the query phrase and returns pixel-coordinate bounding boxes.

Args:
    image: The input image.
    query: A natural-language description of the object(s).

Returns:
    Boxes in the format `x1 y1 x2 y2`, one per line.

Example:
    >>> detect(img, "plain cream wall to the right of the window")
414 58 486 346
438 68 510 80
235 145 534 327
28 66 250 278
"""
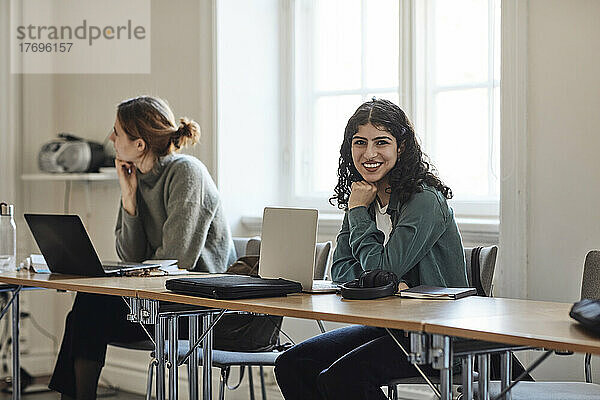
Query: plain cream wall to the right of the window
516 0 600 382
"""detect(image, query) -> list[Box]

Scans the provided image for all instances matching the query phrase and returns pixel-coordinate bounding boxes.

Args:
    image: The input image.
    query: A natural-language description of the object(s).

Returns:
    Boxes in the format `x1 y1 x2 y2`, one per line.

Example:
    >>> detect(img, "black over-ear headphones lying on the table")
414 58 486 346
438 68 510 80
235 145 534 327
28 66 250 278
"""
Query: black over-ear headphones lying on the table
340 269 400 300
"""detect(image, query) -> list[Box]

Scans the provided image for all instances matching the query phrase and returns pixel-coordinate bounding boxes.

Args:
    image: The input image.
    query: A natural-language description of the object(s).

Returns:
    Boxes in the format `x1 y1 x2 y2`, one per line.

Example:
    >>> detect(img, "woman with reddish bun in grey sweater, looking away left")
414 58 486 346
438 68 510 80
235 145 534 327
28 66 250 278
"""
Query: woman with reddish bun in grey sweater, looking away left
49 96 235 399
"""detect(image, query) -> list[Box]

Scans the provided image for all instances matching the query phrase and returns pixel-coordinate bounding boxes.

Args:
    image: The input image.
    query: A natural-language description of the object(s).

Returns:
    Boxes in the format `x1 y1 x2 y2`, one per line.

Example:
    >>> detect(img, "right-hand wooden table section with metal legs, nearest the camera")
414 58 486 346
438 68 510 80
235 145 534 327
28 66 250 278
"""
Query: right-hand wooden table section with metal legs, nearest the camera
423 297 600 400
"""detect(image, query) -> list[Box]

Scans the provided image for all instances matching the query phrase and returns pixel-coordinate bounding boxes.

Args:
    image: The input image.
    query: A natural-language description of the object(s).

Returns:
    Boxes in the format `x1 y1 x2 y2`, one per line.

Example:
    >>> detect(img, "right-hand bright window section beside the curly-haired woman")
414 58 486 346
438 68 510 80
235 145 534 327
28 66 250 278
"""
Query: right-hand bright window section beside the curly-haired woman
415 0 500 215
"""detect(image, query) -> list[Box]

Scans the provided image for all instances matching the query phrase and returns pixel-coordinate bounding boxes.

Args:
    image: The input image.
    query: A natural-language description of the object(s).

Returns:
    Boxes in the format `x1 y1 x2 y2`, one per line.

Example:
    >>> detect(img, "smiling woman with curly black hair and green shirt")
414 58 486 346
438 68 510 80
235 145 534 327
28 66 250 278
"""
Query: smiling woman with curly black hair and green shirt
275 98 467 400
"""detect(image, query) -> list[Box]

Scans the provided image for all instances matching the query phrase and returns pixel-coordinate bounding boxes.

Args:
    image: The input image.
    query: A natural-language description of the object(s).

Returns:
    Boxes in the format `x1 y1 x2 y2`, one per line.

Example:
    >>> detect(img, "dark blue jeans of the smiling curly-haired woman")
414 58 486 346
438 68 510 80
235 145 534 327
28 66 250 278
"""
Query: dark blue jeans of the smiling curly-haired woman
275 326 439 400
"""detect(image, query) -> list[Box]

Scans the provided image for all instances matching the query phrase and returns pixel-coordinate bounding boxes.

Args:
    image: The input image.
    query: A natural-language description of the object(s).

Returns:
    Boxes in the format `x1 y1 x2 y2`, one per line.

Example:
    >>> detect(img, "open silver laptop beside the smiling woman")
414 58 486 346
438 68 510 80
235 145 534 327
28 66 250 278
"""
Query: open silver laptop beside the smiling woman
259 207 337 293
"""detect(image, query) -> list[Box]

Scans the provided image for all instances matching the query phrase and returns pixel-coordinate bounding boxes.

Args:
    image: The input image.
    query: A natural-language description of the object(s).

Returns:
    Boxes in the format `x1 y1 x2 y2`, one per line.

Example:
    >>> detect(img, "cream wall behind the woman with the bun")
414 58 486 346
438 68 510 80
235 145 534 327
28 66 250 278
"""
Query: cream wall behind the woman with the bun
17 0 216 390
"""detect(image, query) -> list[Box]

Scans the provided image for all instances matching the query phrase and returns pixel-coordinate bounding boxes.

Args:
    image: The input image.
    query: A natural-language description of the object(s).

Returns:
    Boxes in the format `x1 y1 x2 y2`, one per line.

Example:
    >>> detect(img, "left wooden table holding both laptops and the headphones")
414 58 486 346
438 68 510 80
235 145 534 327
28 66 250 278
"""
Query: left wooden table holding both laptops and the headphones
0 271 434 399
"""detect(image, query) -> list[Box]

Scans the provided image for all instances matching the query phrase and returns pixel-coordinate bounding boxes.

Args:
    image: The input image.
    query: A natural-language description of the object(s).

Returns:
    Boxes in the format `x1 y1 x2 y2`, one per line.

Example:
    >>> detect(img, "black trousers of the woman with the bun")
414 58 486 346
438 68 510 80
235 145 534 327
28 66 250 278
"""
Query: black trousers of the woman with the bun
48 293 152 398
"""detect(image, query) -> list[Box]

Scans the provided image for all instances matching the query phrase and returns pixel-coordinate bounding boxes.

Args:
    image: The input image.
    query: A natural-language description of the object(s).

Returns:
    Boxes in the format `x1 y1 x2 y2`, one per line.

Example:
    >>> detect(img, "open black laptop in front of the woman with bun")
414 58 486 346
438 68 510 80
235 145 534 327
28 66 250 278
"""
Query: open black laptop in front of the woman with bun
25 214 157 276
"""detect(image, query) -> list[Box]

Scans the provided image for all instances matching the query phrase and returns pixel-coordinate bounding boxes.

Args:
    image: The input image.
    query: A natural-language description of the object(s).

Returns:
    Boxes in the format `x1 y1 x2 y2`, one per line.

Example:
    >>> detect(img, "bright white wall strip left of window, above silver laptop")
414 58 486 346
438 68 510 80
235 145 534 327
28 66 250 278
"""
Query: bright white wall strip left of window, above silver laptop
217 0 285 236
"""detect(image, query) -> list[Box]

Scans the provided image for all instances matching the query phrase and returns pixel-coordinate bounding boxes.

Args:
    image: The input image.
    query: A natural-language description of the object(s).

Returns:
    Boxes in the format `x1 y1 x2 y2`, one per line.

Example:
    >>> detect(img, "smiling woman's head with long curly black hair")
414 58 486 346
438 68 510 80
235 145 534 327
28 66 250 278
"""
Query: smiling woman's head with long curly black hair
329 98 452 214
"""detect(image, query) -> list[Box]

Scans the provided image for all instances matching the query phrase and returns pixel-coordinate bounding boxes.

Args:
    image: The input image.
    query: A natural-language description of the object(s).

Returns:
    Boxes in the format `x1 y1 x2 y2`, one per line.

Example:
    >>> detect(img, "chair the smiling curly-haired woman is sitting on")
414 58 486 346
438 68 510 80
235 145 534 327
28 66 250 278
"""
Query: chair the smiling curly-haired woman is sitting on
384 246 498 400
